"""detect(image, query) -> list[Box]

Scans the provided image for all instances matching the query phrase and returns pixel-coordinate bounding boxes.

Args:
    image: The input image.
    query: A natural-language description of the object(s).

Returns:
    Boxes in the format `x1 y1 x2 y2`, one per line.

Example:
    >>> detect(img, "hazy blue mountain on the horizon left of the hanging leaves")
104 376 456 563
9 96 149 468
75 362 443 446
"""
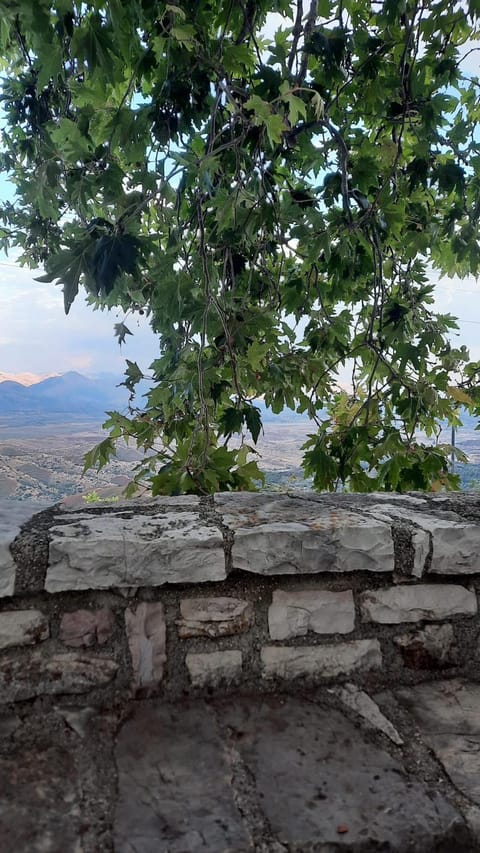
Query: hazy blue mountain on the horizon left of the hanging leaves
0 371 128 422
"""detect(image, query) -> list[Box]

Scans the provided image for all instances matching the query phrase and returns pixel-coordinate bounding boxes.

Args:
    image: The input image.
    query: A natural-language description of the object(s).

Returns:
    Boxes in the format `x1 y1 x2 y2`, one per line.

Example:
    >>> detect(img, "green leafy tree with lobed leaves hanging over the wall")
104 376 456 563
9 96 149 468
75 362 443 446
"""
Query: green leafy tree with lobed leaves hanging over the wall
0 0 480 493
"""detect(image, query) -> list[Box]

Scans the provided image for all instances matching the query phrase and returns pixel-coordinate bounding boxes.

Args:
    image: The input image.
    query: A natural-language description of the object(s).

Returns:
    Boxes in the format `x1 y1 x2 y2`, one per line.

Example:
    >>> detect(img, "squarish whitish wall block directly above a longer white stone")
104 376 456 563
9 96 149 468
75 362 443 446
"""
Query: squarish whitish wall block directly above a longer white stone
268 589 355 640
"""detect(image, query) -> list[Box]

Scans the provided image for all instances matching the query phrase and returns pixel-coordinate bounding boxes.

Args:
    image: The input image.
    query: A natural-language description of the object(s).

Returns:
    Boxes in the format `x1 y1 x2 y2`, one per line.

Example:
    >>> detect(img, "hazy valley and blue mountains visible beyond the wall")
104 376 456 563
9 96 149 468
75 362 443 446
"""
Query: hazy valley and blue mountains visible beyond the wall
0 373 480 505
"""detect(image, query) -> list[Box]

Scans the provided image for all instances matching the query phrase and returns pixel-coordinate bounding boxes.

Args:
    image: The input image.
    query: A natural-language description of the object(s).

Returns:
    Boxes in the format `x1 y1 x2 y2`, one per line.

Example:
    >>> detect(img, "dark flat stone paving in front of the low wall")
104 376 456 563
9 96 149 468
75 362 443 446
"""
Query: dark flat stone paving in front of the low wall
0 679 480 853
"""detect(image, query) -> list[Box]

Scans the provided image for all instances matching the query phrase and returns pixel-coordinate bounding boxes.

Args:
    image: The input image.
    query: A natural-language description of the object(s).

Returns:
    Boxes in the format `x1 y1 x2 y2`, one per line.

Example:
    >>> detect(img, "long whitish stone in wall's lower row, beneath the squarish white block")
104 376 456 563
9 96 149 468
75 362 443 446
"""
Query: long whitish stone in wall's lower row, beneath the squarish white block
261 639 382 679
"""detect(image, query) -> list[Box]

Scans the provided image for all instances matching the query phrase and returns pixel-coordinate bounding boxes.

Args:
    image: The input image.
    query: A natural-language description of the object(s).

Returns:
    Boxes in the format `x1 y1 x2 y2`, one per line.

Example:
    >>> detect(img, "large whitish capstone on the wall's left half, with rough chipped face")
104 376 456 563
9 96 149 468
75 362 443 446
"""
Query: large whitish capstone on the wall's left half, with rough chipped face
45 509 226 592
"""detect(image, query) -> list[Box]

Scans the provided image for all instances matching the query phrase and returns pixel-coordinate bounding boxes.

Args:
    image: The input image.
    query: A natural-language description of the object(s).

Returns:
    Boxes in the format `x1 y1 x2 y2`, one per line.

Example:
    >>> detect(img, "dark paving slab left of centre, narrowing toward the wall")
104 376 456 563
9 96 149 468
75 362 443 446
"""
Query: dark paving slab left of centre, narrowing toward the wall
114 701 253 853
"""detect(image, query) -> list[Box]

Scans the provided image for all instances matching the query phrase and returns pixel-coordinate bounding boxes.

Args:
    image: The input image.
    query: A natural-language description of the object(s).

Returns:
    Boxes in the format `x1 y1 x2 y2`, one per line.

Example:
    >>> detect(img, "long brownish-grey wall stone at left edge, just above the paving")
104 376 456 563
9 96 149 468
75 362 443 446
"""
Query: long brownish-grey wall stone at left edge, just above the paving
0 651 118 703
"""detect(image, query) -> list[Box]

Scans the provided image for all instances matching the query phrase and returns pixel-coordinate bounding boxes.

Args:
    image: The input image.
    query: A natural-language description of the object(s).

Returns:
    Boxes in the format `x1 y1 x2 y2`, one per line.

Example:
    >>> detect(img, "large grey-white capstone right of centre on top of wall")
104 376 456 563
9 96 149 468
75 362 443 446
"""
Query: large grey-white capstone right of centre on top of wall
214 493 394 575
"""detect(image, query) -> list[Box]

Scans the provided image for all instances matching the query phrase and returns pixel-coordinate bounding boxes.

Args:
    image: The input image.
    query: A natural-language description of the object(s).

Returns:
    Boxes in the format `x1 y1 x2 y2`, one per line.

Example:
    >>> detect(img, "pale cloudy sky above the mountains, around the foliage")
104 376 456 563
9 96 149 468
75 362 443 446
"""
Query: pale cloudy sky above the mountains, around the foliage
0 9 480 376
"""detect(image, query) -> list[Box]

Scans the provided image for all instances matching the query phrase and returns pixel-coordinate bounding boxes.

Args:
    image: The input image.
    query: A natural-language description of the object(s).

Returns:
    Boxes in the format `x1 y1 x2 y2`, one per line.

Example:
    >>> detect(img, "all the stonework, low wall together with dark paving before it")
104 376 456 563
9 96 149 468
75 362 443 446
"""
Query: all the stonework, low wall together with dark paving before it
0 494 480 853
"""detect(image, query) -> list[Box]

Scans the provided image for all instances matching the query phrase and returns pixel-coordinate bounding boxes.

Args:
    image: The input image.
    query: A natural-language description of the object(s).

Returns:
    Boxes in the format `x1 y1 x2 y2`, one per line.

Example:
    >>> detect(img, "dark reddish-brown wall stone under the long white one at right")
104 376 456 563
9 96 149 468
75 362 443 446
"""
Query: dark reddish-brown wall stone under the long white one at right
393 624 458 669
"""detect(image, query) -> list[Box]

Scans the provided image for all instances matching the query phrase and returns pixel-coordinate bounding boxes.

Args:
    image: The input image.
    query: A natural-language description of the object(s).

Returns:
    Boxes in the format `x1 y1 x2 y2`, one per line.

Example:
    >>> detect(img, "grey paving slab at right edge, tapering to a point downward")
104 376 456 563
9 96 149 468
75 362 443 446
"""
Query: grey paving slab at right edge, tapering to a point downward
395 679 480 806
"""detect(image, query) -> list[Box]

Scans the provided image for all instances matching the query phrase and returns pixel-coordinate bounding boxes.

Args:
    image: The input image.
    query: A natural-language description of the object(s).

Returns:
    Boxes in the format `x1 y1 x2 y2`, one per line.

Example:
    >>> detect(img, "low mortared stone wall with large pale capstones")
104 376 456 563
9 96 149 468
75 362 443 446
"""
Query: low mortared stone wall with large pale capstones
0 493 480 704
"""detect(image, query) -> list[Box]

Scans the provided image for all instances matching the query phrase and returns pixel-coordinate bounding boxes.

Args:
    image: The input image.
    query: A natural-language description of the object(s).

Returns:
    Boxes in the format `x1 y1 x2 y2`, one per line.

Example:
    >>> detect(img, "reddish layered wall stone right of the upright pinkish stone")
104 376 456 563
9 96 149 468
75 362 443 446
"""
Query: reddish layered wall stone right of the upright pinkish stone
176 596 254 638
